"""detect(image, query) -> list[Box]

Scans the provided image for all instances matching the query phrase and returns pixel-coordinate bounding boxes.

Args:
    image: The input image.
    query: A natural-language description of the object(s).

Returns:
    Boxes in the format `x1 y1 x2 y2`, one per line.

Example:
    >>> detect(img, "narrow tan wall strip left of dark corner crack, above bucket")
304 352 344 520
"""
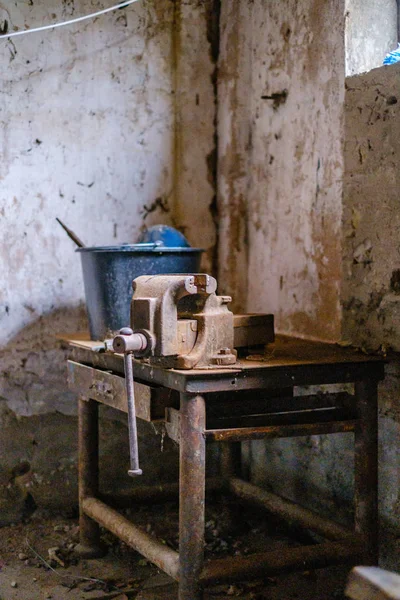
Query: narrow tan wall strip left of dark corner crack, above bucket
173 0 219 273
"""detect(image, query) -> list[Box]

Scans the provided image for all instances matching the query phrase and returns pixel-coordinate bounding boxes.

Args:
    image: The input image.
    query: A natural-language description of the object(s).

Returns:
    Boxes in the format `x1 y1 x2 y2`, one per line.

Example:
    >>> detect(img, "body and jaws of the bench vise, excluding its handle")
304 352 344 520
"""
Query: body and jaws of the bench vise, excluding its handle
131 274 237 369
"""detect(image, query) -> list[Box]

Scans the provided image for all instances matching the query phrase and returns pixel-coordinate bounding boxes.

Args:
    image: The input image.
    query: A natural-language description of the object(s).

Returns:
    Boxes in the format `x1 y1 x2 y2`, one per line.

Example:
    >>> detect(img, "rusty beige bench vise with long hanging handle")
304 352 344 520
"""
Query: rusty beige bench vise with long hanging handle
113 274 273 476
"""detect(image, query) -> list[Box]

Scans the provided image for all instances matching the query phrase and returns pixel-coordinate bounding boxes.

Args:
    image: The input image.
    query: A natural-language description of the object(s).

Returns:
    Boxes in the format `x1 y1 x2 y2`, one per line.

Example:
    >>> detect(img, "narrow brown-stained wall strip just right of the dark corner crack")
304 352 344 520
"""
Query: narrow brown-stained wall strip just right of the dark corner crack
217 0 252 311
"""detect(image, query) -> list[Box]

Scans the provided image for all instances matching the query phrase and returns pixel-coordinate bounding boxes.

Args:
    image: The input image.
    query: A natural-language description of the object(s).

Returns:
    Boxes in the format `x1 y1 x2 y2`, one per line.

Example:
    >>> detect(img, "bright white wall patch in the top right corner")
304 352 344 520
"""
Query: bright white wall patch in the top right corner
345 0 399 75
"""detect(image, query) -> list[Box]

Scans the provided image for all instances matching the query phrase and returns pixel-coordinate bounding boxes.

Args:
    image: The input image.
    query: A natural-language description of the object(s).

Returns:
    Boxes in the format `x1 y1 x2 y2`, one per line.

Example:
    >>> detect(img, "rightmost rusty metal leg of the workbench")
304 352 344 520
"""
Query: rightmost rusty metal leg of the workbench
355 380 379 565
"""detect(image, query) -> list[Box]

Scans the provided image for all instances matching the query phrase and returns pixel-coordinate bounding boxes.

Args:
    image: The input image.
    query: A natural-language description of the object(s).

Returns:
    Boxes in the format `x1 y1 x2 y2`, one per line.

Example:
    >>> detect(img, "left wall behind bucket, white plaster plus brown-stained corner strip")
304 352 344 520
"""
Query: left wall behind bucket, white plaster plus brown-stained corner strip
0 0 216 516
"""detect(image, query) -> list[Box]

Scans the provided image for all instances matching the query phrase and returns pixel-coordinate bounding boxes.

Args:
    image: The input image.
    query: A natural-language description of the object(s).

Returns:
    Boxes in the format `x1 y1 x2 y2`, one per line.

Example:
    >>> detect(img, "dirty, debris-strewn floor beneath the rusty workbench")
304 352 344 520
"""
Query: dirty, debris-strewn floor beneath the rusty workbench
0 499 349 600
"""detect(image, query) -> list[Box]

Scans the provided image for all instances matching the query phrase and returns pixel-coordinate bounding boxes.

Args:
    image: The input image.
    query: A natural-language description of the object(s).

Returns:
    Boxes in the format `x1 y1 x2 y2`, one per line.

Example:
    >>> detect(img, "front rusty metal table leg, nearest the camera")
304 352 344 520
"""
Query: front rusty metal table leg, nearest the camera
179 394 206 600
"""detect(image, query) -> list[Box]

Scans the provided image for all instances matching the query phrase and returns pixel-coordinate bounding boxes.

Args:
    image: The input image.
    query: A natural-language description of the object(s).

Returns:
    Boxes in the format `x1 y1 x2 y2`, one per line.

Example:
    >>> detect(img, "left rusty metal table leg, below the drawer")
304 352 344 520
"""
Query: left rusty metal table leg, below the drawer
75 398 104 558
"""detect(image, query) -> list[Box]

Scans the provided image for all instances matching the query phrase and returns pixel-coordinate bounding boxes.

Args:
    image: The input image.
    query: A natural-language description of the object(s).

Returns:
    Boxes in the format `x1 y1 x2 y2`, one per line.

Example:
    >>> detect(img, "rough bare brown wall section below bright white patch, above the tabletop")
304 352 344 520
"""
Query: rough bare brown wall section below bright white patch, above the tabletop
343 65 400 351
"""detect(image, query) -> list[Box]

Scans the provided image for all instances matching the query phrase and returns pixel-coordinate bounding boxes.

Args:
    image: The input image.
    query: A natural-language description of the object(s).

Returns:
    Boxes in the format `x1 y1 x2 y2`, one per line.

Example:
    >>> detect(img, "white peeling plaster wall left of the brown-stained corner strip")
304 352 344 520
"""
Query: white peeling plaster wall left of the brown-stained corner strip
0 0 174 415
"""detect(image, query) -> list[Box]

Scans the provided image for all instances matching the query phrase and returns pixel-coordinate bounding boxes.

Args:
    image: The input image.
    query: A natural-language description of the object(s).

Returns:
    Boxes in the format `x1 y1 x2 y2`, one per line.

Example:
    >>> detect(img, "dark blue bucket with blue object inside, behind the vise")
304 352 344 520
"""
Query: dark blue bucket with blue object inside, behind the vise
76 227 203 340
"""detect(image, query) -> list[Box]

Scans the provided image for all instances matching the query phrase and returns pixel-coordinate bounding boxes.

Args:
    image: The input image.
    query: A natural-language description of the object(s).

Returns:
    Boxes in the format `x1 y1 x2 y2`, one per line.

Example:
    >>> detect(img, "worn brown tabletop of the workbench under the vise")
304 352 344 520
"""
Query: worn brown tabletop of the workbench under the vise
59 333 385 393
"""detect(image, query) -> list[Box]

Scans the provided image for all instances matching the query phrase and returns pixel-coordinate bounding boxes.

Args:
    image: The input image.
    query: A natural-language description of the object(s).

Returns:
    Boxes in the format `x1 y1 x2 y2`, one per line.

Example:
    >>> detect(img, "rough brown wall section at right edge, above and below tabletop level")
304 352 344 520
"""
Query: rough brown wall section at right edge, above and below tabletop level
343 65 400 569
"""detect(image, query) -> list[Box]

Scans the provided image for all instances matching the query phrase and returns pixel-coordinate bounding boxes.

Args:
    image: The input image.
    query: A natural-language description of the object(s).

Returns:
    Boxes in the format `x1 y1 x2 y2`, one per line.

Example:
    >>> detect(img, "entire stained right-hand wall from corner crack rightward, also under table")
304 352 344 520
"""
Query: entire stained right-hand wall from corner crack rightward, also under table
218 0 400 569
